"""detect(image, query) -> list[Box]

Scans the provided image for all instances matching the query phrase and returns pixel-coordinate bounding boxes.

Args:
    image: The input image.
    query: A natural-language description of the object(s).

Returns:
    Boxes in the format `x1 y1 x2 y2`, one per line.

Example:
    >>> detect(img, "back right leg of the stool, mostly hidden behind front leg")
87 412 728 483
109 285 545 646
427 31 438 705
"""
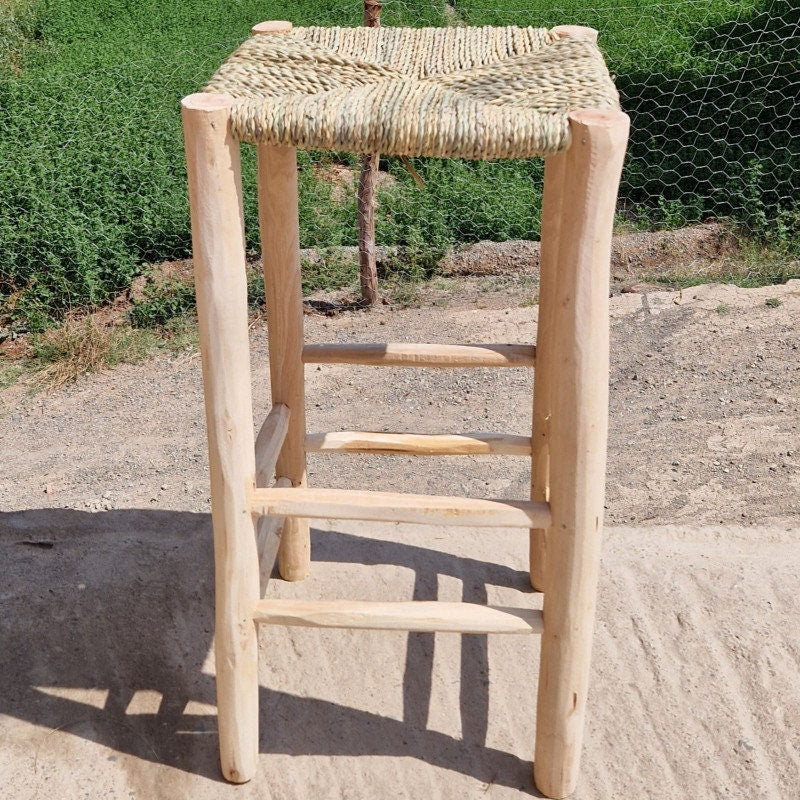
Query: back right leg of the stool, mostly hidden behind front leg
530 153 566 592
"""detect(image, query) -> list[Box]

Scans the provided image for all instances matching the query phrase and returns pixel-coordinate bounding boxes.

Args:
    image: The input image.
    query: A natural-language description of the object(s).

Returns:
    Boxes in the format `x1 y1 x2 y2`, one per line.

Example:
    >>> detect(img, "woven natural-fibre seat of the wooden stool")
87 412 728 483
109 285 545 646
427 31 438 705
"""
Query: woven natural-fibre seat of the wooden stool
205 26 619 159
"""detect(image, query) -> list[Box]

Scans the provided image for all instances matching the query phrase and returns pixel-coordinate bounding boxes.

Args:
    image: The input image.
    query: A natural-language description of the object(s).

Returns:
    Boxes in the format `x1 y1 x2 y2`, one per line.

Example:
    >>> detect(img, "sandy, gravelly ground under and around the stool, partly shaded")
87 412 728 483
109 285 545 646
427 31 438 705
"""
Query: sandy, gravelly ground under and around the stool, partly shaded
0 281 800 800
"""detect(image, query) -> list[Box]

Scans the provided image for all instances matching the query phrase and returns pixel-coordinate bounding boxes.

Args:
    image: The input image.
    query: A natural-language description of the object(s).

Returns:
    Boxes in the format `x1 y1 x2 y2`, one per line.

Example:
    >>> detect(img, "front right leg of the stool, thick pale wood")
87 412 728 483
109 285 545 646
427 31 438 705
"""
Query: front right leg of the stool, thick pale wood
534 110 629 798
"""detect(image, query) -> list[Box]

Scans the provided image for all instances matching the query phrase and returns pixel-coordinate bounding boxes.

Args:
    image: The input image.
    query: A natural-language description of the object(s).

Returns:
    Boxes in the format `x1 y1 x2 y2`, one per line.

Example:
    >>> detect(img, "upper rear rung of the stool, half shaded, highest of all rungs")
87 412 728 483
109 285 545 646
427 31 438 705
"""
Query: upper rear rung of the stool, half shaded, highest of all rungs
303 342 536 367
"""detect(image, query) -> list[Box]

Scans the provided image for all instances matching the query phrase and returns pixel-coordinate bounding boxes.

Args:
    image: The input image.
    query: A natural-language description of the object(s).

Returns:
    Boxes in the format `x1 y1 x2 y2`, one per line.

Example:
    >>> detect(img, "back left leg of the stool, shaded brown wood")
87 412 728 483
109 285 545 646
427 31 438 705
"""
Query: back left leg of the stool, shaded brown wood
258 144 311 581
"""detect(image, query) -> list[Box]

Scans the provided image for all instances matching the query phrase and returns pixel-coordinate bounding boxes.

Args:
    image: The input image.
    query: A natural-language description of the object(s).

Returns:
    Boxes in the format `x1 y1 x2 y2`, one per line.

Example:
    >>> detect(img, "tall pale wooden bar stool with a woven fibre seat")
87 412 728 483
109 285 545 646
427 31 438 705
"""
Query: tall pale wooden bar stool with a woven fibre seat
183 22 628 797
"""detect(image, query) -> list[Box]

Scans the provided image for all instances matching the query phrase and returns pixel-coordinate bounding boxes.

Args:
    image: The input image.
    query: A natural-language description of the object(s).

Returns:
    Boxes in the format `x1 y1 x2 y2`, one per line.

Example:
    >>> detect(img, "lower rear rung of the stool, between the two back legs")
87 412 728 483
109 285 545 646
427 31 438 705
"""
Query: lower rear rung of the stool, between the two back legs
306 431 531 456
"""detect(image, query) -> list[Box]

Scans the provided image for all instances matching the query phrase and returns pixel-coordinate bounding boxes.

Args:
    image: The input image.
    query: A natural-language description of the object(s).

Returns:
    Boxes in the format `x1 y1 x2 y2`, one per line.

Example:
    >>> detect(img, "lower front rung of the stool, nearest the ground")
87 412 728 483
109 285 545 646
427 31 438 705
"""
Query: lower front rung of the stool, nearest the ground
254 600 542 634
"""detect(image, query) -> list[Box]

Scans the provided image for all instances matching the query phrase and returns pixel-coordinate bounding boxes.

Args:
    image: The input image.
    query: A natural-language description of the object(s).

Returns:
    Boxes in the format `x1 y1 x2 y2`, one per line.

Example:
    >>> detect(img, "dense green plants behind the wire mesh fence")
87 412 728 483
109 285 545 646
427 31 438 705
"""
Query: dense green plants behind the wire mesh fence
0 0 800 328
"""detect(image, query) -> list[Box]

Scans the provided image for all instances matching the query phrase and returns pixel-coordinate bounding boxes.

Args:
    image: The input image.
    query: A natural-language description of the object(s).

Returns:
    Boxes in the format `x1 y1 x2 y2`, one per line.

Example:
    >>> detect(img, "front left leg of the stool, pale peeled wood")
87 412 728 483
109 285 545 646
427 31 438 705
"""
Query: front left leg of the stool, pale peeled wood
182 94 259 783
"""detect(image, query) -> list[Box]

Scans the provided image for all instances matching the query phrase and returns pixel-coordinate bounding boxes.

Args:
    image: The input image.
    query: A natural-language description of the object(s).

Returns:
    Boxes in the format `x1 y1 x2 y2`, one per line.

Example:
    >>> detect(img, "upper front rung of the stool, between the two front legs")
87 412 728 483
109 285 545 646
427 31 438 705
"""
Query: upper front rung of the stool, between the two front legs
250 488 550 528
